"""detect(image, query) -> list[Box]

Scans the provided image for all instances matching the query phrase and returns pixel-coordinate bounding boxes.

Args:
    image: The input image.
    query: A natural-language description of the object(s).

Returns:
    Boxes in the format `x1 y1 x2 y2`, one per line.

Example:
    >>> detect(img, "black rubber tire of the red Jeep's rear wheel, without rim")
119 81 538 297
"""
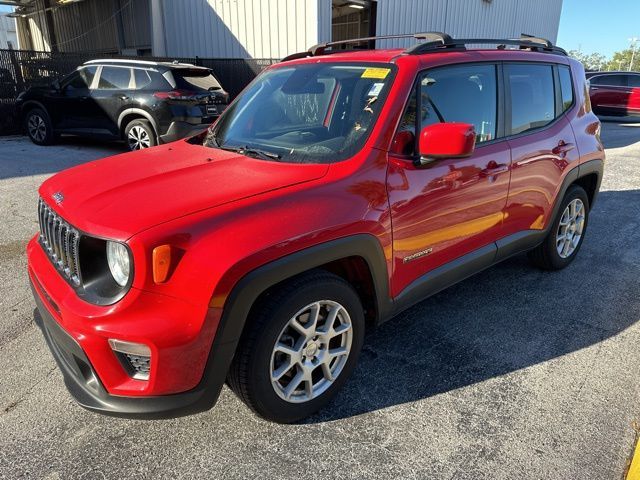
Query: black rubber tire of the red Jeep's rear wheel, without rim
529 185 590 270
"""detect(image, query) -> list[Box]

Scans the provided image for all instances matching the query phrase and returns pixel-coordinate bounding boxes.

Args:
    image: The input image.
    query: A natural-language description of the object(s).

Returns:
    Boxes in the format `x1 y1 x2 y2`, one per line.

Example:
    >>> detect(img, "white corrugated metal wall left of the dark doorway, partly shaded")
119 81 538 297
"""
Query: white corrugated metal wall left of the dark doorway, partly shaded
162 0 324 58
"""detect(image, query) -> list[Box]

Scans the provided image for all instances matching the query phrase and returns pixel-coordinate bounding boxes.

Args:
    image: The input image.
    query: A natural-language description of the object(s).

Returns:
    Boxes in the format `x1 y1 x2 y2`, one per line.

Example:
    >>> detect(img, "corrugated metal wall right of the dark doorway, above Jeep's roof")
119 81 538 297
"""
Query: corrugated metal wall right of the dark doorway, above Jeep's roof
377 0 562 47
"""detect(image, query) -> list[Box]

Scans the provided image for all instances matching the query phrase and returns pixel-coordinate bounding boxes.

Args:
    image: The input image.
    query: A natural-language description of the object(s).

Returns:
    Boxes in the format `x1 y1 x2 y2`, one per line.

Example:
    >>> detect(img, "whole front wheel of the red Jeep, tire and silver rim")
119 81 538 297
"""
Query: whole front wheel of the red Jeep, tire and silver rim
228 272 364 423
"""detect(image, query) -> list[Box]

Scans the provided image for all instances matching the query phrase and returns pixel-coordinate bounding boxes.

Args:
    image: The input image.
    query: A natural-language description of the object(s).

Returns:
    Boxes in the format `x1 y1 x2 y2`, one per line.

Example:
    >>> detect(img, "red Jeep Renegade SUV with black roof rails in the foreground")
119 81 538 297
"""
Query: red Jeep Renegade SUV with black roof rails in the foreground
27 33 605 422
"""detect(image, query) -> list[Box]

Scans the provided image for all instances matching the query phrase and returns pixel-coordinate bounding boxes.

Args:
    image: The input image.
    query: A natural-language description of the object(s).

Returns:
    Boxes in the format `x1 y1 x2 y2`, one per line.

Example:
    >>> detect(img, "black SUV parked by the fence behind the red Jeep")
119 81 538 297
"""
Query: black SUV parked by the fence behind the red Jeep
18 60 229 150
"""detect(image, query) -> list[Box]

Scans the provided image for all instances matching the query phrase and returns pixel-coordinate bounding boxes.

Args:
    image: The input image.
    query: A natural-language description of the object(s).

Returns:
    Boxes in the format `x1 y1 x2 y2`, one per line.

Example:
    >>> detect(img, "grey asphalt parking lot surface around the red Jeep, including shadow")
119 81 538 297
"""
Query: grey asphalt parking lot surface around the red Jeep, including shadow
0 122 640 480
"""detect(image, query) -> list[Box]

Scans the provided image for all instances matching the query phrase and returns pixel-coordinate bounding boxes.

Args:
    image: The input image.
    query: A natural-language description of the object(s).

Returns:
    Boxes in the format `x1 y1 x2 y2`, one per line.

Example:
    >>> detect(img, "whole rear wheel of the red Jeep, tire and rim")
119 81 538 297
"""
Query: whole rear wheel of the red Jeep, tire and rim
529 185 589 270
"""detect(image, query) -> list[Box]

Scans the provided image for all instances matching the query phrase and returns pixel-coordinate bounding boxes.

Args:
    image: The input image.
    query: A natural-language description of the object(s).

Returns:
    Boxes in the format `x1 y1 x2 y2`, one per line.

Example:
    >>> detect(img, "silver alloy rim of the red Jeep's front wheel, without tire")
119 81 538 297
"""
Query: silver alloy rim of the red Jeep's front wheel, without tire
270 300 353 403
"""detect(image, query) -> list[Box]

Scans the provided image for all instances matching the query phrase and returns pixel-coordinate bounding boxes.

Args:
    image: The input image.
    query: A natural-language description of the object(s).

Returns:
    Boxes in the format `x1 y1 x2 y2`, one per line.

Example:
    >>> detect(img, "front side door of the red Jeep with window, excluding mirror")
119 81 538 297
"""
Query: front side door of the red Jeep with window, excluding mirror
387 63 511 296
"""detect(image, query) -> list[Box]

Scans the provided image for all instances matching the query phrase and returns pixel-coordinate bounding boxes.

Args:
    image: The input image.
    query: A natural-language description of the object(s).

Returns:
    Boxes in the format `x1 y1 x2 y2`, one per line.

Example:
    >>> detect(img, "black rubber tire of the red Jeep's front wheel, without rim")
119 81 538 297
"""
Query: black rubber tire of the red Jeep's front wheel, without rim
227 271 365 423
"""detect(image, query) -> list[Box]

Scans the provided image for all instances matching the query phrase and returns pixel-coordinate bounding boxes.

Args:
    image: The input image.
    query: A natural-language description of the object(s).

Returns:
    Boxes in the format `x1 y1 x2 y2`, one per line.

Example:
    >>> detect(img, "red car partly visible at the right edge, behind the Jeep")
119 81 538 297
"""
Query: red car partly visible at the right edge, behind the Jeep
586 72 640 116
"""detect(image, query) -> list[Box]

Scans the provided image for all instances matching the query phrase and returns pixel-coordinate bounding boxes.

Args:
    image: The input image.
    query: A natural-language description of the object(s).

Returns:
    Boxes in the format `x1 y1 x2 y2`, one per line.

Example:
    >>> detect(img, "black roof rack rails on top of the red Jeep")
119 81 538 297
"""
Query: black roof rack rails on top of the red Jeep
281 32 567 62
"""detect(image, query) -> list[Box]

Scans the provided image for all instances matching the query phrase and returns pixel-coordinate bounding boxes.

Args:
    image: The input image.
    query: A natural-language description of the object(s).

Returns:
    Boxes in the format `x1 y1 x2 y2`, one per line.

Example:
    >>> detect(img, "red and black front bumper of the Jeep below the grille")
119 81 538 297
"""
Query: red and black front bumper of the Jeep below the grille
27 240 235 418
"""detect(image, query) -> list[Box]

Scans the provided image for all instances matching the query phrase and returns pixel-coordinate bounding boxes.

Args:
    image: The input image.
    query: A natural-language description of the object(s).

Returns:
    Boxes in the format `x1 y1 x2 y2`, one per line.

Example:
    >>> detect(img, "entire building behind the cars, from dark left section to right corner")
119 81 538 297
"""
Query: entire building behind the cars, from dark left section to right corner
12 0 562 58
